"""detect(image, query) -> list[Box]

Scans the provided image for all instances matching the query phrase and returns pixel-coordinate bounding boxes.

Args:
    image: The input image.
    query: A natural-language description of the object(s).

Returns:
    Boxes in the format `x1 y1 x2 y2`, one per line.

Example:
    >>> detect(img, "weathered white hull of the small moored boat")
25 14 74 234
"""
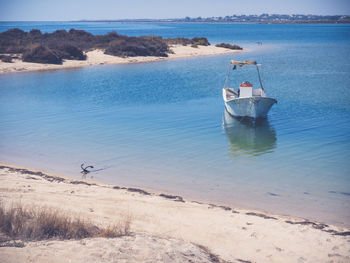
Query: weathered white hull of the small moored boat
225 97 277 118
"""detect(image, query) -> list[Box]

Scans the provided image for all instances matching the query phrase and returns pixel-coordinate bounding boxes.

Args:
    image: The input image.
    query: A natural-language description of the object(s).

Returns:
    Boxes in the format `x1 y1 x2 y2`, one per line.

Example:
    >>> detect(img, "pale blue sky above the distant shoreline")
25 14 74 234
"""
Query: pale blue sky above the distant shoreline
0 0 350 21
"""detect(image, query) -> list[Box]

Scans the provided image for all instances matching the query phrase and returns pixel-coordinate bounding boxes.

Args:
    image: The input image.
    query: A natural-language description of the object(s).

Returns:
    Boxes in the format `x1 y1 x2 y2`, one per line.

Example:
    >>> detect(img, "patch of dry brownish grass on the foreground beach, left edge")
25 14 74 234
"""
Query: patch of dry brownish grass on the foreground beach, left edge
0 203 131 242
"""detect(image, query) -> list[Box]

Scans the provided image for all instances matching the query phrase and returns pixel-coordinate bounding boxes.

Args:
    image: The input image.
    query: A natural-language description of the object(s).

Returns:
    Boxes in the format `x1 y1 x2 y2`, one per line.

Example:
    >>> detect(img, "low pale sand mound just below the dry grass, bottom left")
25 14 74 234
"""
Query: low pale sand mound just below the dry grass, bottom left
0 234 223 263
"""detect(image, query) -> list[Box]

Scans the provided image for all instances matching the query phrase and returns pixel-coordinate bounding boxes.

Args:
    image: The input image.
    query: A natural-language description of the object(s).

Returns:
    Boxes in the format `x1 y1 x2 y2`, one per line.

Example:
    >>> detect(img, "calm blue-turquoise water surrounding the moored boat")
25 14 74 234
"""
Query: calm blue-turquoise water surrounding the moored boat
0 23 350 225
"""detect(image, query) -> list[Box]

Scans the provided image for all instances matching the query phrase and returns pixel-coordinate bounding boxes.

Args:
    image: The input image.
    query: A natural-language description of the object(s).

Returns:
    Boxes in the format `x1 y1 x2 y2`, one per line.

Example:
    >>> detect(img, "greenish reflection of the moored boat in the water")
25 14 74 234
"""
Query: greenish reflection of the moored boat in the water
223 109 277 156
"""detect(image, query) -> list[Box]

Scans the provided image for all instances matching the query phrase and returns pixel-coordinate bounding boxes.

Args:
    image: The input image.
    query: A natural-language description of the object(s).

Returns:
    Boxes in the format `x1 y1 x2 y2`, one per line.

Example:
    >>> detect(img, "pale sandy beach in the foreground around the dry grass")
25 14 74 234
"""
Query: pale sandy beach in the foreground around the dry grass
0 164 350 262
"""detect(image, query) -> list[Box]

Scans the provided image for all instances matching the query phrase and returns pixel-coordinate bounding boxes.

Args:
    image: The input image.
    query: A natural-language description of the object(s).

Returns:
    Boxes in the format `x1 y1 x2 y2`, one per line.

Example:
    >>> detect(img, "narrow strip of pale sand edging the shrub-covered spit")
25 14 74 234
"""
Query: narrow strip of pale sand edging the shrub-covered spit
0 45 241 74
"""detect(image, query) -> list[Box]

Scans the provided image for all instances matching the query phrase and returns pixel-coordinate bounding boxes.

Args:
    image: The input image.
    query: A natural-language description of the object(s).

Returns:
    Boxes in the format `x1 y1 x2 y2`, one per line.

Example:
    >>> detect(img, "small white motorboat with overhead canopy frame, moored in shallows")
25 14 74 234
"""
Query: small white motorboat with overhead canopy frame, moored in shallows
222 60 277 118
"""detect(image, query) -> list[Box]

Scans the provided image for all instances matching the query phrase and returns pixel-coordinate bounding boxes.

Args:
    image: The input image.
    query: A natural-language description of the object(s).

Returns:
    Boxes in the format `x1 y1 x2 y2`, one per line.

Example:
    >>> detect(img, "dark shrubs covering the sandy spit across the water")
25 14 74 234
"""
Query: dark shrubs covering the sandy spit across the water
0 28 239 64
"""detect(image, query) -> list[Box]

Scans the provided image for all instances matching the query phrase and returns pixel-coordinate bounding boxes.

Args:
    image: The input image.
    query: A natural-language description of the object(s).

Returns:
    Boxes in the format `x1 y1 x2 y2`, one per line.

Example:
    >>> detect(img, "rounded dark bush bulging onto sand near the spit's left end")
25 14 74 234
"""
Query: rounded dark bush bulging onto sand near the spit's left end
23 45 62 64
